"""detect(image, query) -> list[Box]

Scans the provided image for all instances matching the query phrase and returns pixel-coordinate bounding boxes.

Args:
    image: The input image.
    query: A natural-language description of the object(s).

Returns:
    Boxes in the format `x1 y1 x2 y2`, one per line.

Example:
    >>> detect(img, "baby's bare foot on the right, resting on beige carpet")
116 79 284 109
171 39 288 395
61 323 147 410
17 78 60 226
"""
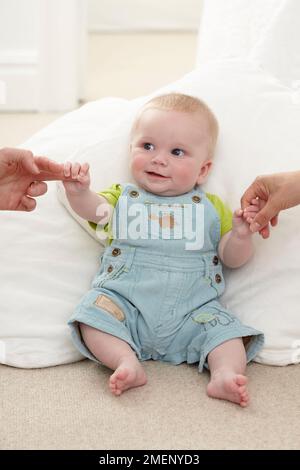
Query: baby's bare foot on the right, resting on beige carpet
207 371 249 407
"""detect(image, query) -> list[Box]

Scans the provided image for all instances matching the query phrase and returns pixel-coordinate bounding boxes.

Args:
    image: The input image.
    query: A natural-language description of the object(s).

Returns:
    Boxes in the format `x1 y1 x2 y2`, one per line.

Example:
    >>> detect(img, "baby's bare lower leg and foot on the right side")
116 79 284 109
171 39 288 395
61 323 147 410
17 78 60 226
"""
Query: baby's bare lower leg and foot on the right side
207 338 249 406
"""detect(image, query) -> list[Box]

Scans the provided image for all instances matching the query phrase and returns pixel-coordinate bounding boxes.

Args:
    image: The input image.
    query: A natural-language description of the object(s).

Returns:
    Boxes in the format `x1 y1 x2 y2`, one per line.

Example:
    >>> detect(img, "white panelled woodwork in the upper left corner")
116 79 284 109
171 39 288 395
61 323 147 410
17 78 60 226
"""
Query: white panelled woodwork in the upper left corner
0 0 87 111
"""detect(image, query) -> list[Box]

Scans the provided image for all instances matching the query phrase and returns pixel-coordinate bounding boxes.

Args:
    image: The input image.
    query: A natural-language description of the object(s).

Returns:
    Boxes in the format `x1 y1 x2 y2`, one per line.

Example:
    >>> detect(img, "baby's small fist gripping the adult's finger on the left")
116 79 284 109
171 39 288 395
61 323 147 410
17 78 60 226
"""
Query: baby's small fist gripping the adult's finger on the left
63 162 91 194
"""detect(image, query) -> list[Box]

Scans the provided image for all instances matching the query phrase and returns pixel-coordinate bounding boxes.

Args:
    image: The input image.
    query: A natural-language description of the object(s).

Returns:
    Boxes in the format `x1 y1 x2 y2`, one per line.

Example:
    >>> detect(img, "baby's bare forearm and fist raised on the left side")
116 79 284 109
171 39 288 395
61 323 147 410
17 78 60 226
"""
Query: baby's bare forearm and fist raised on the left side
63 162 113 224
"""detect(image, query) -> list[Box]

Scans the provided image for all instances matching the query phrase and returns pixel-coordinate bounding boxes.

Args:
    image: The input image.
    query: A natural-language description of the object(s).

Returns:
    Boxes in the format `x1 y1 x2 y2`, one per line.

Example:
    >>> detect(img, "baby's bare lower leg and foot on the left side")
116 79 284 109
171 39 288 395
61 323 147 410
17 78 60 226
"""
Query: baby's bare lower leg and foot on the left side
80 323 147 395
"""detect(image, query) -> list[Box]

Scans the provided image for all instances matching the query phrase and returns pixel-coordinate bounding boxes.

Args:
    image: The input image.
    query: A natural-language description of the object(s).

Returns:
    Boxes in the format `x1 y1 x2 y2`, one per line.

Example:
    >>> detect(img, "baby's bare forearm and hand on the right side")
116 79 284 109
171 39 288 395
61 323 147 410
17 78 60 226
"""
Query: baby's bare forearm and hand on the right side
218 203 259 268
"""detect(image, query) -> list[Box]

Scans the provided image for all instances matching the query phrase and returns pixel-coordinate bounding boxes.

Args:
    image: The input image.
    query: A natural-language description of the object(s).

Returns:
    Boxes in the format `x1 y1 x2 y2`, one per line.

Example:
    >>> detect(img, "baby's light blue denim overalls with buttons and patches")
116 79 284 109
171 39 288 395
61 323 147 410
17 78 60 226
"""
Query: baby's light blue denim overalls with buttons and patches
68 184 264 372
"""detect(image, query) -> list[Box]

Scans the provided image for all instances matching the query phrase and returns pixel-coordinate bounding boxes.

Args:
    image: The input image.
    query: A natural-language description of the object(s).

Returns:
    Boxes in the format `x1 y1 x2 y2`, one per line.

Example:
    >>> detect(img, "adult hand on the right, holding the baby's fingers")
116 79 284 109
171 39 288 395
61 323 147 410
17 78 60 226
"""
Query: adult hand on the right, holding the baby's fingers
241 171 300 238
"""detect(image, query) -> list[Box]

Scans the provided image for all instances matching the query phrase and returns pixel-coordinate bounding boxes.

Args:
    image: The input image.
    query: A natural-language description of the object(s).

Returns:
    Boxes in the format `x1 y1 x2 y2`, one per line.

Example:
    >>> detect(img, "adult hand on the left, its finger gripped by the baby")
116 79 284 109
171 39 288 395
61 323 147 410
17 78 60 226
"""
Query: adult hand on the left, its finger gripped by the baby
0 148 64 211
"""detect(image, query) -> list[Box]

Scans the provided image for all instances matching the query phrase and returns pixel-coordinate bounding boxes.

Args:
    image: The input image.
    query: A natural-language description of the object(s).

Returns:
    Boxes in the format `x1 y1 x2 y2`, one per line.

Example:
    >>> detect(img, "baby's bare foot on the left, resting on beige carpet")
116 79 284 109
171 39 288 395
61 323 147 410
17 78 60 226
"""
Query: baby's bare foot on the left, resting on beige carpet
109 361 147 396
